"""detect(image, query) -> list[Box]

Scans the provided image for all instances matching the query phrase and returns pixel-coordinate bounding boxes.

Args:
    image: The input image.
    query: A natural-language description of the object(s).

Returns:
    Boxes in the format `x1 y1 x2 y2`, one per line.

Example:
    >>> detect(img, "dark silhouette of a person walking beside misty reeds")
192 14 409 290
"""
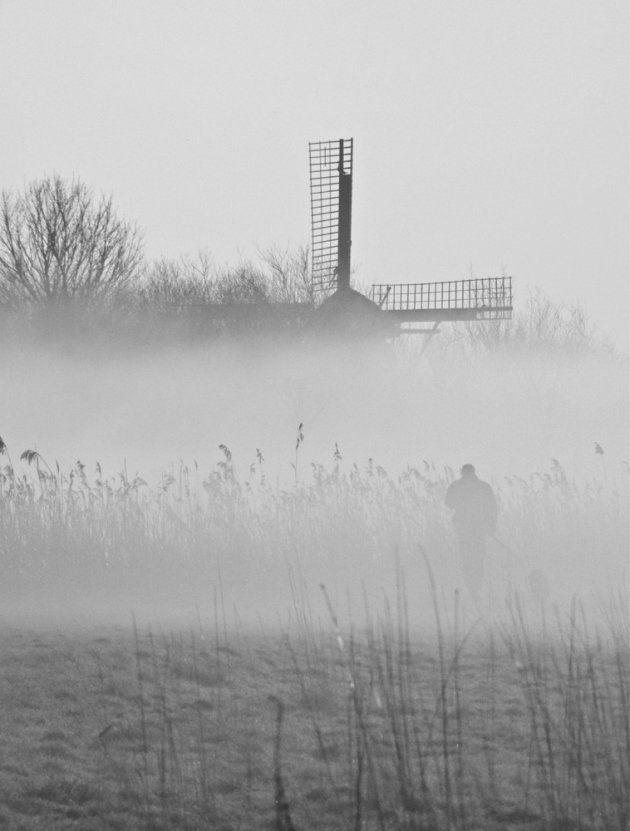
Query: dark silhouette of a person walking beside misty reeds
444 464 497 600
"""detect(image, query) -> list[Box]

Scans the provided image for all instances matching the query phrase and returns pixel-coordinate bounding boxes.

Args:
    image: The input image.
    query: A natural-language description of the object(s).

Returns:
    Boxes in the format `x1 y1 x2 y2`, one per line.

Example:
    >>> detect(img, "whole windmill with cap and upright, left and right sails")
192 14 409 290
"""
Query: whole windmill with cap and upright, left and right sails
184 138 512 341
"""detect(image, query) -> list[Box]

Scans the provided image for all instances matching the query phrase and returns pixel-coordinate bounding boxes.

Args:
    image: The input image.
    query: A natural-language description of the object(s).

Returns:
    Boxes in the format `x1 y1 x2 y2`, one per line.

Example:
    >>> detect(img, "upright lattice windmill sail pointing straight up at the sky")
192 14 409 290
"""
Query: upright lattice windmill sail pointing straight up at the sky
308 139 352 295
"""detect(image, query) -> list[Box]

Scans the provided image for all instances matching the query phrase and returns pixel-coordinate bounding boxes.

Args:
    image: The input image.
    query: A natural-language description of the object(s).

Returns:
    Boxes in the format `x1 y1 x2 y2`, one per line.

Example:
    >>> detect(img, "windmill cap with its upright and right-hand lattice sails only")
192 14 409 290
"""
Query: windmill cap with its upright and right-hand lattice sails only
309 139 512 336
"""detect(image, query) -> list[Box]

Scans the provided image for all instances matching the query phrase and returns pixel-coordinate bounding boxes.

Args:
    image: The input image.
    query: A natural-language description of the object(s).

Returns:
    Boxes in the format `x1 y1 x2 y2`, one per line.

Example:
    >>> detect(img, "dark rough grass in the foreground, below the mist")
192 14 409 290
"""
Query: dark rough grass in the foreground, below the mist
0 588 630 831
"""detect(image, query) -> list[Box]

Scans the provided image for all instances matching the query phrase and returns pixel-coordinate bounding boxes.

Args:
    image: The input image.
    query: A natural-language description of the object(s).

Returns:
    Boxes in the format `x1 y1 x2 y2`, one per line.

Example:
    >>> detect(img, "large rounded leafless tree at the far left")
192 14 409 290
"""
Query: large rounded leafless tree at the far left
0 176 143 308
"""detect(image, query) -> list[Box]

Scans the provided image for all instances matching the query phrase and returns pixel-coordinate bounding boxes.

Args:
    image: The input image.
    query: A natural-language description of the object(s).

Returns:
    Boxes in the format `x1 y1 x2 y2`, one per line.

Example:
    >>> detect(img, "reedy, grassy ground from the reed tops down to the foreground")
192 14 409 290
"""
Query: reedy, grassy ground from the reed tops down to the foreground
0 432 630 831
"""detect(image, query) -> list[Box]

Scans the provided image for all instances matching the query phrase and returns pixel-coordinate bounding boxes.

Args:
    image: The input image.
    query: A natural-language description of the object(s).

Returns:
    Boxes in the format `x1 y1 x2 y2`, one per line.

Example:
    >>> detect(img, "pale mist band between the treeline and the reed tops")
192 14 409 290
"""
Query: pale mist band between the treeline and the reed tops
0 338 628 484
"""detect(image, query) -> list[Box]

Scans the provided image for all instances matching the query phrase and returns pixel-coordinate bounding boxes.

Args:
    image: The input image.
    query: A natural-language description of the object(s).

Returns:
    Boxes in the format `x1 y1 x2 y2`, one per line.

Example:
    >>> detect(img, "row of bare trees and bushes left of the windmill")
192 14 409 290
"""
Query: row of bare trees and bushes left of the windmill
0 176 312 310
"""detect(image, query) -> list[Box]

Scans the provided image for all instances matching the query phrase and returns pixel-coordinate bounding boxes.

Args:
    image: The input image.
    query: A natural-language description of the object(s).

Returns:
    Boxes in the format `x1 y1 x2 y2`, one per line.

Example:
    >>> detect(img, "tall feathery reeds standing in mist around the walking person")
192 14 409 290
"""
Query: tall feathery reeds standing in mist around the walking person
0 442 628 616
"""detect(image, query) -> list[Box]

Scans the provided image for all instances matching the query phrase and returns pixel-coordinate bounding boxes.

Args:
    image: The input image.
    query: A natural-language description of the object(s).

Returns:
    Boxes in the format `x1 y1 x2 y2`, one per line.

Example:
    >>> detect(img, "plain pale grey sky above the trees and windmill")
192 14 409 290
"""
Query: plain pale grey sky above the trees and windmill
0 0 629 343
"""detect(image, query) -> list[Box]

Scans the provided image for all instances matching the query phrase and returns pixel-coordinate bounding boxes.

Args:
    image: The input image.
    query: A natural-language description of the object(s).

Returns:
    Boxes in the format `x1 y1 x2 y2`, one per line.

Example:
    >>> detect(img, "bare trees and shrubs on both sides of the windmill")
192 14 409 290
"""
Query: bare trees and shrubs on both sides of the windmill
0 176 608 351
